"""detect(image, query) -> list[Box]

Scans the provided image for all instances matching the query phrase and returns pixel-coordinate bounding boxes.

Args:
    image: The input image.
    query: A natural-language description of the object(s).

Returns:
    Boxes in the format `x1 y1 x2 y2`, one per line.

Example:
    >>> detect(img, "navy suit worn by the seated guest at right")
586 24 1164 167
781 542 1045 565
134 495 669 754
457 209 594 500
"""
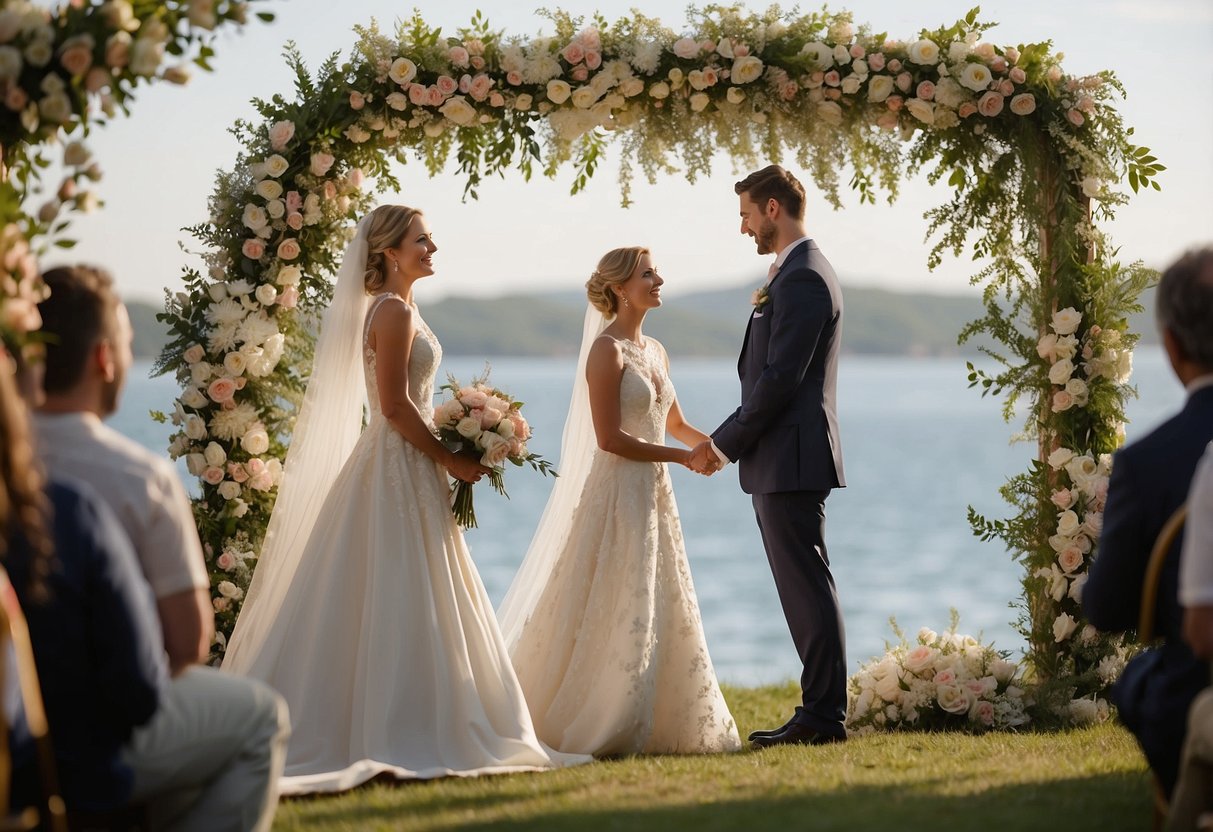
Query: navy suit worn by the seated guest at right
1082 387 1213 792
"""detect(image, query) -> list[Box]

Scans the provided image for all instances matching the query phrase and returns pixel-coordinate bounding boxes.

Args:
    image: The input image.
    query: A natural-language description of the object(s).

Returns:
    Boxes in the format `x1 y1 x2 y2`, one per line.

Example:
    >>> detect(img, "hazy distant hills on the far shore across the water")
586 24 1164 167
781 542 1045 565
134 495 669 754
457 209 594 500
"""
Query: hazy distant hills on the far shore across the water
127 285 1157 358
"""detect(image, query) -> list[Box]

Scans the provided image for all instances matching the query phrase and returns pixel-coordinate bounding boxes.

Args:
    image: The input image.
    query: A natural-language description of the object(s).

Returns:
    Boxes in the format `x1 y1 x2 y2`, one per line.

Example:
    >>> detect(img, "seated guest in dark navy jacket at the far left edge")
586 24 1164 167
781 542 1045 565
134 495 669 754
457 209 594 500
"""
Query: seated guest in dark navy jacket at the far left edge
0 349 169 810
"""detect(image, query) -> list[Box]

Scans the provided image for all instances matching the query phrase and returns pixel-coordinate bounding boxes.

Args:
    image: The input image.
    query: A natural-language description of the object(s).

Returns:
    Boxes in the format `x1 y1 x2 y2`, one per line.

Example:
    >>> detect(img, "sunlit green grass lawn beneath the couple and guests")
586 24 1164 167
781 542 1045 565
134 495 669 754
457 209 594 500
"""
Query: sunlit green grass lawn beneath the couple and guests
274 685 1150 832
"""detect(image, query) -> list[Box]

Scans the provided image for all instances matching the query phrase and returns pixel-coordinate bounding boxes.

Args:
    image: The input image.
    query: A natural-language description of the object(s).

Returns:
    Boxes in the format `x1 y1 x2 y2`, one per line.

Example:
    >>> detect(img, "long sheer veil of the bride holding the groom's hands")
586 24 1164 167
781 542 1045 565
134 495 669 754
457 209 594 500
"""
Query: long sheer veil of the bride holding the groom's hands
497 304 609 653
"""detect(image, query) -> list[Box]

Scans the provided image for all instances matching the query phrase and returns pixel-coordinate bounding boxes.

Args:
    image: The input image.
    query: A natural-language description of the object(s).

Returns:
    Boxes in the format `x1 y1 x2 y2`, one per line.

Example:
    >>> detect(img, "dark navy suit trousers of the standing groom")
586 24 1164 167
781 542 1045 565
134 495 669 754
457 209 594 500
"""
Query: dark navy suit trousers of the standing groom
752 491 847 736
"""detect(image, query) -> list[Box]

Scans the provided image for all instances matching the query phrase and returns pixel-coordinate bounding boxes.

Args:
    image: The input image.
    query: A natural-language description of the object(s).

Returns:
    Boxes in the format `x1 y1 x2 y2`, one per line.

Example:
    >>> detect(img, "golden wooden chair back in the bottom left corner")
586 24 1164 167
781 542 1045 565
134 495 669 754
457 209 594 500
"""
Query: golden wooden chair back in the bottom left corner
0 566 68 832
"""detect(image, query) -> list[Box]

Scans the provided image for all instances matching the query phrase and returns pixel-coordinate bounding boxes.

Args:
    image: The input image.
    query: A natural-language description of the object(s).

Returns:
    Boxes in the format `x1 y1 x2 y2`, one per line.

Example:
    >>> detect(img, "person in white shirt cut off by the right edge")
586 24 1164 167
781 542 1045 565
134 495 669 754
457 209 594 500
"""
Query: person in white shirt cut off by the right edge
1167 445 1213 832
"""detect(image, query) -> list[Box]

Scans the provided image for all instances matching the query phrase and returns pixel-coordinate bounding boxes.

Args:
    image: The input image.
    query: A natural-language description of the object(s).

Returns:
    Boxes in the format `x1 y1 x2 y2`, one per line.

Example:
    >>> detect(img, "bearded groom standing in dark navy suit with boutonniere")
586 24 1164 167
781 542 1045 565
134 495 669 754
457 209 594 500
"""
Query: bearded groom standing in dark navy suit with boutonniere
693 165 847 748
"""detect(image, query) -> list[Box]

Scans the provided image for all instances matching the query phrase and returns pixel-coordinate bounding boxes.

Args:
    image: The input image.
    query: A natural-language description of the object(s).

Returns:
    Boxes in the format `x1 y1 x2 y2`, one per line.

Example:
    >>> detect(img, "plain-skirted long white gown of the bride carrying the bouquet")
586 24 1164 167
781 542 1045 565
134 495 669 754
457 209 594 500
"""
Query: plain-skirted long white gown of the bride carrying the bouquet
230 295 588 794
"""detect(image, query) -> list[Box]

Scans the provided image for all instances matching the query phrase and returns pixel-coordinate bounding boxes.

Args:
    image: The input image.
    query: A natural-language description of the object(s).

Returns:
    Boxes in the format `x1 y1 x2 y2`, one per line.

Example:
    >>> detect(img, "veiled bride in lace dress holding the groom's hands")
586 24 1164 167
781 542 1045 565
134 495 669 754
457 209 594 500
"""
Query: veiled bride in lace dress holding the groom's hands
500 247 741 757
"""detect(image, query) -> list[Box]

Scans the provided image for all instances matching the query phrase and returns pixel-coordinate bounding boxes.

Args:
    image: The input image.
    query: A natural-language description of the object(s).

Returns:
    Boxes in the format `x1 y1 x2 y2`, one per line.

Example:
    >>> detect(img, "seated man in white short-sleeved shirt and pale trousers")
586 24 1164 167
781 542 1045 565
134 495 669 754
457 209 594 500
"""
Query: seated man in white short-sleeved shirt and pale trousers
35 267 289 830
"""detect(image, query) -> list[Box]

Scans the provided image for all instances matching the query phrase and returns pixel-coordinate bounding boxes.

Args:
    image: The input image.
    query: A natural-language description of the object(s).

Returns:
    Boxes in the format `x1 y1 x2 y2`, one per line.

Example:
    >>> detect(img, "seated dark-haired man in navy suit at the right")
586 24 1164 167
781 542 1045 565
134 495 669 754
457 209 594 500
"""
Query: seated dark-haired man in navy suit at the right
1082 247 1213 793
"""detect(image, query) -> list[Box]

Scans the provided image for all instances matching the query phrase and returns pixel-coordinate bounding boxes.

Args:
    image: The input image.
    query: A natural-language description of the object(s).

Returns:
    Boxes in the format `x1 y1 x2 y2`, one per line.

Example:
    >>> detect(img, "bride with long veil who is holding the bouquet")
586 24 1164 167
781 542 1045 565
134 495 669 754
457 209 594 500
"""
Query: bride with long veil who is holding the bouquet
223 205 587 794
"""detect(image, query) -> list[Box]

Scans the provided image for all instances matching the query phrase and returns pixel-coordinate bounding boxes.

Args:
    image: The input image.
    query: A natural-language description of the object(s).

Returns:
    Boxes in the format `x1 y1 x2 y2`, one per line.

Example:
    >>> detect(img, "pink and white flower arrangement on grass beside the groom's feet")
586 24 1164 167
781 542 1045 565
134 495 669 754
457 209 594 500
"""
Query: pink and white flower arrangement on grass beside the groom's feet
847 611 1029 734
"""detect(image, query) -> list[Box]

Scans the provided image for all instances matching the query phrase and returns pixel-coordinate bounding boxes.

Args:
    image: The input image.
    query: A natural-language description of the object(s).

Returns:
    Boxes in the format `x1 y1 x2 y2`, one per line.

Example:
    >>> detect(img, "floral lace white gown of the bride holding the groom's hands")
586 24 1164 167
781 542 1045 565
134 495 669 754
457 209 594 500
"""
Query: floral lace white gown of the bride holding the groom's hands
511 338 741 757
